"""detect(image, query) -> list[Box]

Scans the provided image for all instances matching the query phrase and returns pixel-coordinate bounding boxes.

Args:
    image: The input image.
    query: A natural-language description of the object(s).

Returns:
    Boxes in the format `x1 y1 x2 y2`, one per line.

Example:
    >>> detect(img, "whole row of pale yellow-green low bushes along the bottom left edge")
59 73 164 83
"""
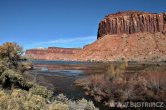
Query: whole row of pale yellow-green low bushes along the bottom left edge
0 89 97 110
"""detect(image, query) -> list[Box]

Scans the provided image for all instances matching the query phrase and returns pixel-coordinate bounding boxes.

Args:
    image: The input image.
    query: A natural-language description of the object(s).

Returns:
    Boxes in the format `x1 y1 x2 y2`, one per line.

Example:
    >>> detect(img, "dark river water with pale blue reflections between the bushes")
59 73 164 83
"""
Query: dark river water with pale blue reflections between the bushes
30 60 166 110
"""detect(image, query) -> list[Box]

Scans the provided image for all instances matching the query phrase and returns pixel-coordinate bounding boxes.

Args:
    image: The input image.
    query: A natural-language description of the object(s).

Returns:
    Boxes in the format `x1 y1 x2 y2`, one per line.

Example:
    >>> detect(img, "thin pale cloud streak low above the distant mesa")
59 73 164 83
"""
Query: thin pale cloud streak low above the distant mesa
35 36 96 47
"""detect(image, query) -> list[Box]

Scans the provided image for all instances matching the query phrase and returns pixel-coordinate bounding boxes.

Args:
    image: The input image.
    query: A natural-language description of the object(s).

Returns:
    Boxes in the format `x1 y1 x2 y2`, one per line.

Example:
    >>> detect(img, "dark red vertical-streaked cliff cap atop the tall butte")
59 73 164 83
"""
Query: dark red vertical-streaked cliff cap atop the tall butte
97 11 166 39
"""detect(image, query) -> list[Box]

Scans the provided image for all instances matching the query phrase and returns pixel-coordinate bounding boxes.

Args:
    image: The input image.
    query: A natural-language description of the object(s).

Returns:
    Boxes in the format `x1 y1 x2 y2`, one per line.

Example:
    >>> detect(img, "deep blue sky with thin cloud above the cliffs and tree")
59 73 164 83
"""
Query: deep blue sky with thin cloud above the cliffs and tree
0 0 166 50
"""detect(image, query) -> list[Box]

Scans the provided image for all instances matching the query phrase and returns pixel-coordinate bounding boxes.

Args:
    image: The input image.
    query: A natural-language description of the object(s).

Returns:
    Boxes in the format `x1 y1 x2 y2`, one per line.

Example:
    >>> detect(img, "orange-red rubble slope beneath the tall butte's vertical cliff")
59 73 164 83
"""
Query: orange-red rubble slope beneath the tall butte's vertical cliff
75 33 166 61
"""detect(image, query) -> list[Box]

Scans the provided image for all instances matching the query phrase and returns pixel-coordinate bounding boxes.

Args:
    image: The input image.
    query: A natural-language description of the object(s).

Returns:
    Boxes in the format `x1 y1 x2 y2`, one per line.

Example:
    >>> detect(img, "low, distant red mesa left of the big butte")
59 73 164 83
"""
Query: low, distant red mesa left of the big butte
25 47 82 60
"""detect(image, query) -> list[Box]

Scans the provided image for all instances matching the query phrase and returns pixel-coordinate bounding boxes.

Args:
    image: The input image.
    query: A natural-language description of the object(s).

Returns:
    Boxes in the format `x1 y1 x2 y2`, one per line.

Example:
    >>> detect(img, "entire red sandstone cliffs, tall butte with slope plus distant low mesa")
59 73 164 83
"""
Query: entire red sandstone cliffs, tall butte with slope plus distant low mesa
26 11 166 61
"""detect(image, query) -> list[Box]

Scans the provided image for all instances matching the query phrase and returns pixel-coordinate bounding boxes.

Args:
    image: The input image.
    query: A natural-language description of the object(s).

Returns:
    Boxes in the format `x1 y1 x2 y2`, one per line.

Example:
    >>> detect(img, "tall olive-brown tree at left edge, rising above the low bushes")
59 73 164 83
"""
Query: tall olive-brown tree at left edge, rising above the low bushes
0 42 32 90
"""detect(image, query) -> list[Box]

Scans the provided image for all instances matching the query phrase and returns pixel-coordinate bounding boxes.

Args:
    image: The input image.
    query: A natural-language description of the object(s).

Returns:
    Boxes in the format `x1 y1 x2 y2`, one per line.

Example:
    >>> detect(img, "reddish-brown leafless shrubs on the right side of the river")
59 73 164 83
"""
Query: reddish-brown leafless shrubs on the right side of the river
75 62 166 109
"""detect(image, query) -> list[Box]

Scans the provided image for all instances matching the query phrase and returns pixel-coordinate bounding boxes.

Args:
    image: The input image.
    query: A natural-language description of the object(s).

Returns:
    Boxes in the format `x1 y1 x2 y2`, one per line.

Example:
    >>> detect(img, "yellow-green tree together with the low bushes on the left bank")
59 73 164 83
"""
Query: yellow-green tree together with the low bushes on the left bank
0 42 97 110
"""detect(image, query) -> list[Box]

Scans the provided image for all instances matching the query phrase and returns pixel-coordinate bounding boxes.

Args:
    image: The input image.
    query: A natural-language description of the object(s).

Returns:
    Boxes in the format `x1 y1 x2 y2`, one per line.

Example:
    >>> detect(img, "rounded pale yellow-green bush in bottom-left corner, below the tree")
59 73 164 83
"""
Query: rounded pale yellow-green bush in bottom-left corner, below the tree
0 89 46 110
